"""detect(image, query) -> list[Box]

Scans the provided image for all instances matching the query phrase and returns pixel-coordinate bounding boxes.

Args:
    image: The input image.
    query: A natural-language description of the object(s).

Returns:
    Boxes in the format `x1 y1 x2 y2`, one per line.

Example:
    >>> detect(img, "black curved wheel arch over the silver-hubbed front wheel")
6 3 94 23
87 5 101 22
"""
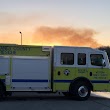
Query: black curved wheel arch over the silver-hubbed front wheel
70 77 93 91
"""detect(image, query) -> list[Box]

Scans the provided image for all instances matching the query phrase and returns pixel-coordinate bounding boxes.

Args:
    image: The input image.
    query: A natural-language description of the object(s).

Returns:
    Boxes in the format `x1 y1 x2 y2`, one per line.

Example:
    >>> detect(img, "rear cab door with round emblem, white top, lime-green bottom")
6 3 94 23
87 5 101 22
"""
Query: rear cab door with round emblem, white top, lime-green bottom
53 47 75 91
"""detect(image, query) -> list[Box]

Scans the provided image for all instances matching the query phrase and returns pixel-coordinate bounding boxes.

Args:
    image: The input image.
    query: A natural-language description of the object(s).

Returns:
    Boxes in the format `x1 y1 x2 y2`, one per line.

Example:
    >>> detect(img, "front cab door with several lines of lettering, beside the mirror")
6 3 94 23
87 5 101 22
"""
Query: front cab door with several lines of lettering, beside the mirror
88 53 109 91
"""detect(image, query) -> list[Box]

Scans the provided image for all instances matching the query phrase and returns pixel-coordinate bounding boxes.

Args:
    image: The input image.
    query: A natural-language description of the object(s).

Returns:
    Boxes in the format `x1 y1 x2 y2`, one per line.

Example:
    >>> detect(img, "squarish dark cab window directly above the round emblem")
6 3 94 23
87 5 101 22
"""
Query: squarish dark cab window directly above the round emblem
61 53 74 65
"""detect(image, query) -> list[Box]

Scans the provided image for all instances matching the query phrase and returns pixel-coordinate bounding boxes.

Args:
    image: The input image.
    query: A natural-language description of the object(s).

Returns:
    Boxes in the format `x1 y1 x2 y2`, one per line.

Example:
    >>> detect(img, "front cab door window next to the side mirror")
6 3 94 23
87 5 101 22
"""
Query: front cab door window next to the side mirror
90 54 104 66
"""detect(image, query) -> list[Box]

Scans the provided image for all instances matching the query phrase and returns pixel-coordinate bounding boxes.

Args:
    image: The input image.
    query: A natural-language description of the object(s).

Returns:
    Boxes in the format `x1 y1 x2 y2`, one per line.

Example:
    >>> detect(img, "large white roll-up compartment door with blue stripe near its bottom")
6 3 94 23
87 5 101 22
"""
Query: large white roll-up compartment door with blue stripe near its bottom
12 57 50 90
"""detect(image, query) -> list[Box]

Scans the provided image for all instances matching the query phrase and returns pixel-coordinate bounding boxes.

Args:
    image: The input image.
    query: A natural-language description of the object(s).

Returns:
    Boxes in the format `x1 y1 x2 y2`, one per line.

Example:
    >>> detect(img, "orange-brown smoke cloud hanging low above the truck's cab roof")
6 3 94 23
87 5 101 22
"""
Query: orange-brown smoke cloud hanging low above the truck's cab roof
33 26 100 47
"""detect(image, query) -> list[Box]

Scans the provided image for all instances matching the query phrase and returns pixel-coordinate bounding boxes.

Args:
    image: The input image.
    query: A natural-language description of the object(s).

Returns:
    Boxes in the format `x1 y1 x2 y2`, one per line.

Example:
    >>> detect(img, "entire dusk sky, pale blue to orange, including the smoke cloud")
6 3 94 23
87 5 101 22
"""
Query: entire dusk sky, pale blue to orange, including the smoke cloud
0 0 110 47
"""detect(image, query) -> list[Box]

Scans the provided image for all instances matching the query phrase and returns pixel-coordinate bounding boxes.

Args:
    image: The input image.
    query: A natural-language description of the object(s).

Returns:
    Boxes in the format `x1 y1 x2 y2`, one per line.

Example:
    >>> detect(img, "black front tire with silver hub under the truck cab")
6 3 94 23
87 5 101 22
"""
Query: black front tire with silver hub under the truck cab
70 81 91 101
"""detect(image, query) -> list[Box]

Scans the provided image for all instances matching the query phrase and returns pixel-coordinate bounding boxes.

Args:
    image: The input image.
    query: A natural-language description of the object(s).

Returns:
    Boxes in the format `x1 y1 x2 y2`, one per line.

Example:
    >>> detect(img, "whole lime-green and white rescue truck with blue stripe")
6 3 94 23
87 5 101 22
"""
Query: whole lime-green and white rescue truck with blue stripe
0 44 110 100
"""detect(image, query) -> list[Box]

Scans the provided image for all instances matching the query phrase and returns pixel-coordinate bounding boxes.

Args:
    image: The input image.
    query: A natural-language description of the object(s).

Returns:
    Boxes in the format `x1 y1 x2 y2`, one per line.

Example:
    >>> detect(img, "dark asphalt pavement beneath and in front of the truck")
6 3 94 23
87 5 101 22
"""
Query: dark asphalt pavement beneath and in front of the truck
0 93 110 110
